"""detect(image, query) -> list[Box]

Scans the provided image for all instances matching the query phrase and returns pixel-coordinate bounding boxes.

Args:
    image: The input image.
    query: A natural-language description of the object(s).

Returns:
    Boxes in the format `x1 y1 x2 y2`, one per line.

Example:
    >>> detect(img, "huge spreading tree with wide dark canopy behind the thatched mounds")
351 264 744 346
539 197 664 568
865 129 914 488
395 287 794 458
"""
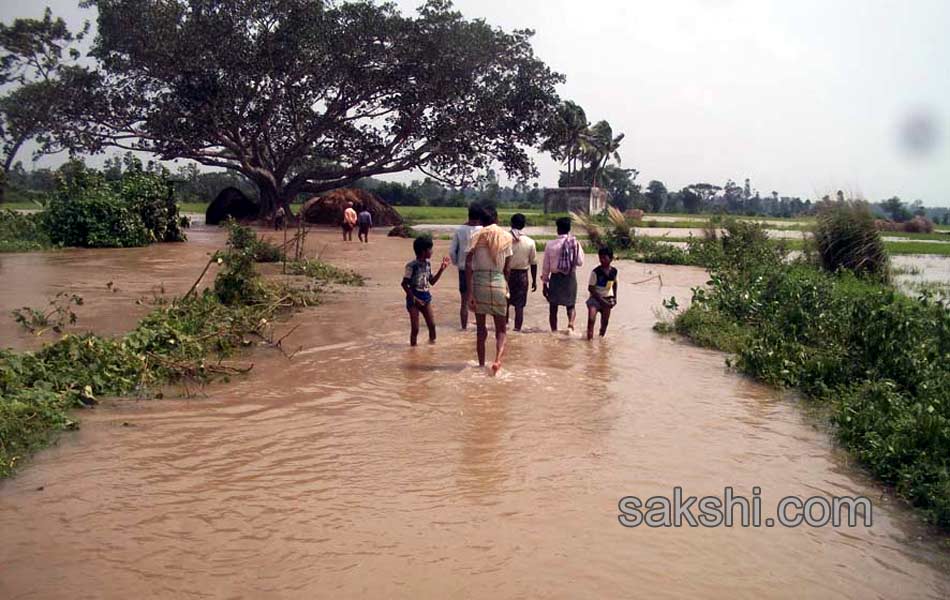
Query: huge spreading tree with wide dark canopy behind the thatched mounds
61 0 563 214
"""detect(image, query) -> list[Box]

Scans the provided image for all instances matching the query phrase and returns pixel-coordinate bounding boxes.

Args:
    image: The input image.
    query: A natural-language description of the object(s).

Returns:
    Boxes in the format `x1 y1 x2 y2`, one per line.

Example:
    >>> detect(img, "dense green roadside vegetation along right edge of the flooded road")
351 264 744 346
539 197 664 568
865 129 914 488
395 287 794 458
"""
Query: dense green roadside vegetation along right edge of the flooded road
661 209 950 527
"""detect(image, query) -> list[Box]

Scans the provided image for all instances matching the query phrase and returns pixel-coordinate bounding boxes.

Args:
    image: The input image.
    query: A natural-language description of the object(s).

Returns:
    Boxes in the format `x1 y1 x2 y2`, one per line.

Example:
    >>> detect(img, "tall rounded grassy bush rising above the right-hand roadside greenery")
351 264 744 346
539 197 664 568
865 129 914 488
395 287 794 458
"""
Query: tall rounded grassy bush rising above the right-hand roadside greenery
815 201 889 280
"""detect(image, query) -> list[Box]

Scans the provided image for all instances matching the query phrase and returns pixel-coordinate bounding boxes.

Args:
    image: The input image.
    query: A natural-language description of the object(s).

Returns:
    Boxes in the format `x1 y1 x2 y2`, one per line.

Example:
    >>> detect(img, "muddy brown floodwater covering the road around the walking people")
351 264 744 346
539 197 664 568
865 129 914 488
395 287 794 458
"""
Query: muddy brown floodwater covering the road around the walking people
0 231 950 599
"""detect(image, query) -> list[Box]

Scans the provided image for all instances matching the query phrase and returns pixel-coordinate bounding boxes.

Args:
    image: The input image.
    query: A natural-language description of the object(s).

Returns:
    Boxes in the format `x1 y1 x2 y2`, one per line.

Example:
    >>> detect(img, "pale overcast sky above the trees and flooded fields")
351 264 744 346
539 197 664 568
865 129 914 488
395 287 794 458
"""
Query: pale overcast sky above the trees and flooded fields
0 0 950 206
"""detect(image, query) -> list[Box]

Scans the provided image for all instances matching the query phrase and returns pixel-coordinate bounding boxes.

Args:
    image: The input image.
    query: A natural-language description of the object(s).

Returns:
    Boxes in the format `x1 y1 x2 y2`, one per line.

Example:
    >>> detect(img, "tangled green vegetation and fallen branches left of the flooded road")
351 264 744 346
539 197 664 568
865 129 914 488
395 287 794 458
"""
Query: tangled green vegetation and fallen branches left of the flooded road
0 224 361 477
